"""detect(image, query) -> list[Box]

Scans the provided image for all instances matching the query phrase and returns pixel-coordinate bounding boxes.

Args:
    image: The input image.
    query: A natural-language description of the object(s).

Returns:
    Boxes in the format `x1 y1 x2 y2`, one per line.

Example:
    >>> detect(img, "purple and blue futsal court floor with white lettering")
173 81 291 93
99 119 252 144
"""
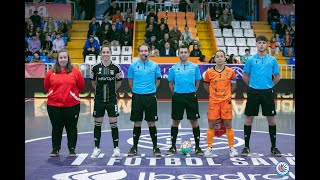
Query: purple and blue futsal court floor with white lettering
25 98 295 180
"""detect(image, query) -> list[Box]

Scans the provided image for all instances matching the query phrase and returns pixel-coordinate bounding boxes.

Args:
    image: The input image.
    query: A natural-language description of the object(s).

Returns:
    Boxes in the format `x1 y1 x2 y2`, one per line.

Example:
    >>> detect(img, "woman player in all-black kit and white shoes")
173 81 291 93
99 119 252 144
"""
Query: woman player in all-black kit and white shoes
90 46 122 158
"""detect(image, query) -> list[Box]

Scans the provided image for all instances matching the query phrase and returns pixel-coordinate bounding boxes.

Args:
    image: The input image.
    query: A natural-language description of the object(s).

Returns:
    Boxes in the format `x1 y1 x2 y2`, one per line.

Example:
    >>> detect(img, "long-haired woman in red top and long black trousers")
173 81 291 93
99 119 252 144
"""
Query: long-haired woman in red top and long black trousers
44 49 85 156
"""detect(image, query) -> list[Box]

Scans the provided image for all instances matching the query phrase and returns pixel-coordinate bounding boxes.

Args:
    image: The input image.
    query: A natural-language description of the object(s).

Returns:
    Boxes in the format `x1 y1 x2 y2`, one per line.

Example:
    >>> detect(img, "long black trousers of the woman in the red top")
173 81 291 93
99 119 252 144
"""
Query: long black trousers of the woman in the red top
47 104 80 150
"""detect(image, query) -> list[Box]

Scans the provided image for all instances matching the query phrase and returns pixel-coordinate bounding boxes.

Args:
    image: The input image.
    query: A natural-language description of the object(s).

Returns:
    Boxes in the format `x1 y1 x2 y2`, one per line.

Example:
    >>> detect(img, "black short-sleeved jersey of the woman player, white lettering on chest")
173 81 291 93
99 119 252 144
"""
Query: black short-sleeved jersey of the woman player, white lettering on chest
90 62 122 102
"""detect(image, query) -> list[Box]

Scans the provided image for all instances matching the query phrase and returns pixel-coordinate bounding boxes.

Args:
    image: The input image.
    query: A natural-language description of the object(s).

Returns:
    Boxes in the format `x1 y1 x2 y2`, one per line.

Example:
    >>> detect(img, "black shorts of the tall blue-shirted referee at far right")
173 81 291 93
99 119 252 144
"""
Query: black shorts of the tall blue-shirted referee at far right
244 88 277 116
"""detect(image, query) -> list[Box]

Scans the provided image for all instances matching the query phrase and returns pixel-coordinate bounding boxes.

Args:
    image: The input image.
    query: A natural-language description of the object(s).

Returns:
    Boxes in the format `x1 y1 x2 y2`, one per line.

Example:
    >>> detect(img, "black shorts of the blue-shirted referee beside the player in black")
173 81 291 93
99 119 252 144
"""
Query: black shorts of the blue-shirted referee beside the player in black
130 93 158 122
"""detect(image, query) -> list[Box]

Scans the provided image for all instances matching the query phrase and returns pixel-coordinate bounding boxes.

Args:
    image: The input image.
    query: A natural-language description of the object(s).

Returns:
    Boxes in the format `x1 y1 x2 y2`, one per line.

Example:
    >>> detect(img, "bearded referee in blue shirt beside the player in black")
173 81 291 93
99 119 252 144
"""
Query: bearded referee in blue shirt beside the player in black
128 43 161 156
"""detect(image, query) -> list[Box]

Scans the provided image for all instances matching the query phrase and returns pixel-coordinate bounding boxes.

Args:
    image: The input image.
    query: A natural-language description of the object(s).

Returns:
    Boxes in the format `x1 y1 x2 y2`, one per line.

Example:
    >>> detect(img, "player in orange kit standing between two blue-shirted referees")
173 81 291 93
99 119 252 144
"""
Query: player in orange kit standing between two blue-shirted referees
203 50 238 157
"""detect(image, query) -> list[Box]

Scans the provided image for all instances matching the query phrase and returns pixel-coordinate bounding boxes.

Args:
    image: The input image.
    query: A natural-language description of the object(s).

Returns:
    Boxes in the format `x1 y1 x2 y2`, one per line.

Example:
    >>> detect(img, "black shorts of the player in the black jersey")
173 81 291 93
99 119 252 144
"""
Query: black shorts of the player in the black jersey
93 101 119 118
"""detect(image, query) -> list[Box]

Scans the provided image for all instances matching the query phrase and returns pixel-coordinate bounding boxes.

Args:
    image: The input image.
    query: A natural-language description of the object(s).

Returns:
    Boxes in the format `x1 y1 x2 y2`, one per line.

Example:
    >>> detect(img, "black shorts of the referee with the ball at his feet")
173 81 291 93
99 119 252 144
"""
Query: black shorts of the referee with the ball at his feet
171 92 200 120
